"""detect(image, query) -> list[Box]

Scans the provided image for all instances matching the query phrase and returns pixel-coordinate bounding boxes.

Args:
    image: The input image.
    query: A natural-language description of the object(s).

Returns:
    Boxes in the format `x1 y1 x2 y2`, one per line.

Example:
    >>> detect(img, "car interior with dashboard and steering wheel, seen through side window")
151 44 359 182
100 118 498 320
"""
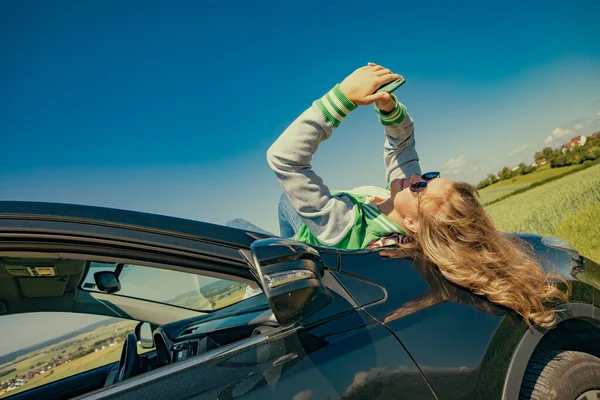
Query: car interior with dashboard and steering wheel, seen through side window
0 256 278 399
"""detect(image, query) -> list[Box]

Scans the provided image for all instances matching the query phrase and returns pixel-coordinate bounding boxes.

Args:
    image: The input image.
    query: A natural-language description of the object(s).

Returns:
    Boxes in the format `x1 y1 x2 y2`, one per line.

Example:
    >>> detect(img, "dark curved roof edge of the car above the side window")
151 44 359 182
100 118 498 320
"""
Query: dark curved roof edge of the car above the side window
0 201 338 276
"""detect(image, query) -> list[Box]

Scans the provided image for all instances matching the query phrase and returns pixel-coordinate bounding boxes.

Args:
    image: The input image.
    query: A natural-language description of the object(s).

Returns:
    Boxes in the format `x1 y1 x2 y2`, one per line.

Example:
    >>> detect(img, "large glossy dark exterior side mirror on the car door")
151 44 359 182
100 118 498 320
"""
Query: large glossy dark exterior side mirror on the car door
250 238 333 326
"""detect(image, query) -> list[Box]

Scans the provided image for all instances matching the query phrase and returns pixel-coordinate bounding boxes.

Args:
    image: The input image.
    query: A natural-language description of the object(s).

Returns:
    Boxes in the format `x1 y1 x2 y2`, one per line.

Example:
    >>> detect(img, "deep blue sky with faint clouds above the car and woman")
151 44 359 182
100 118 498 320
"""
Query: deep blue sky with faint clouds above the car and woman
0 0 600 236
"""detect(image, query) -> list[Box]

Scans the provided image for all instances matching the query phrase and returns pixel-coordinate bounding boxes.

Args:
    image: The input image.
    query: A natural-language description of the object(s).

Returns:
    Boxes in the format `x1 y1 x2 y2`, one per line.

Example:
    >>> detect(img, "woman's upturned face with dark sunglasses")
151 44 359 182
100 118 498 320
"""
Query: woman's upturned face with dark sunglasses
390 174 452 231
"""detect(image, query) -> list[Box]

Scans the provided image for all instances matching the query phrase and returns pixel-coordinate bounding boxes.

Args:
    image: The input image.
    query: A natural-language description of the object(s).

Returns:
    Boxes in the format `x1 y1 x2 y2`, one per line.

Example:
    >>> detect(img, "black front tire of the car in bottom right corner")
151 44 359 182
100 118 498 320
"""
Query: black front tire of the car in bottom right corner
519 350 600 400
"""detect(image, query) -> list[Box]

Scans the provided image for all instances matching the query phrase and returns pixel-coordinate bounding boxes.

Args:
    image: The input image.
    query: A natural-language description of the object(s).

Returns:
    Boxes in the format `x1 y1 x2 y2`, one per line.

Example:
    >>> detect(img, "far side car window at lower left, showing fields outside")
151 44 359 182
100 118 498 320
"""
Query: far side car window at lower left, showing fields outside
0 312 139 398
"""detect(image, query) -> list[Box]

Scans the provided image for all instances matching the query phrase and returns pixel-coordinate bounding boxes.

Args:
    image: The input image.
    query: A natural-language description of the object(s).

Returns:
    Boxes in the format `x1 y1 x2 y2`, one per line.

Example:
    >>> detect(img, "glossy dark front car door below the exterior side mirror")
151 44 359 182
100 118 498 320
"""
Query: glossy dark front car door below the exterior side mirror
81 240 434 399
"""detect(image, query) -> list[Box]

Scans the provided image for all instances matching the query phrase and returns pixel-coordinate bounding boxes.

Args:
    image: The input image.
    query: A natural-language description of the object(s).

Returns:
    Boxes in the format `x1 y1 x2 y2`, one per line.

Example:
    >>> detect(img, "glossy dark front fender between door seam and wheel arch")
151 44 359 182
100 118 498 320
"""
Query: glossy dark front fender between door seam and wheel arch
335 249 524 399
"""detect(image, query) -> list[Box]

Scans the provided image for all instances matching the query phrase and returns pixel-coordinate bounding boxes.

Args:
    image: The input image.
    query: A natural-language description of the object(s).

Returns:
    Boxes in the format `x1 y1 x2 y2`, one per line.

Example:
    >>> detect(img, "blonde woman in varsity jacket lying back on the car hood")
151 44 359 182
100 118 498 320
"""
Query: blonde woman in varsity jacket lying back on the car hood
258 63 568 327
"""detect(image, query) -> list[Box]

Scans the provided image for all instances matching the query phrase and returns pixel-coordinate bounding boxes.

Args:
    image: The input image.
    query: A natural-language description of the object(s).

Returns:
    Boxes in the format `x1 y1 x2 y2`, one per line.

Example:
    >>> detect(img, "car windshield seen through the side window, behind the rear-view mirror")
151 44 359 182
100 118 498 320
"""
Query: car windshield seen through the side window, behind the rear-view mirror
82 262 253 312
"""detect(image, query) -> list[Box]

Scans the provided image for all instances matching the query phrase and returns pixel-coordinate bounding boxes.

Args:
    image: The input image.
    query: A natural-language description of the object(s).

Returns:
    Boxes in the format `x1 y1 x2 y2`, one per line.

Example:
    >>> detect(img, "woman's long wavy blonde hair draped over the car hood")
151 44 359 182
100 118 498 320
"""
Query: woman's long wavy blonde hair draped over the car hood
402 182 571 328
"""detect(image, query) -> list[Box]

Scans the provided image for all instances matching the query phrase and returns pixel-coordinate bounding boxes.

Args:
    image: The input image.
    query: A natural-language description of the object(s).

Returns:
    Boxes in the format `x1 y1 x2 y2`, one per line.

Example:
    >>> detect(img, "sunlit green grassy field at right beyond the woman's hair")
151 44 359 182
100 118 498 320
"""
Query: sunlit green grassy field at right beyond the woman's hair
486 165 600 261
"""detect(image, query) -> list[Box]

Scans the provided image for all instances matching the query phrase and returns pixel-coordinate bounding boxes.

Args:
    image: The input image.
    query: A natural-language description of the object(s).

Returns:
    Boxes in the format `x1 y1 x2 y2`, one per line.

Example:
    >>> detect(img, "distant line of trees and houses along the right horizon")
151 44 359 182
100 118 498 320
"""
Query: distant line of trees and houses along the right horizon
477 135 600 189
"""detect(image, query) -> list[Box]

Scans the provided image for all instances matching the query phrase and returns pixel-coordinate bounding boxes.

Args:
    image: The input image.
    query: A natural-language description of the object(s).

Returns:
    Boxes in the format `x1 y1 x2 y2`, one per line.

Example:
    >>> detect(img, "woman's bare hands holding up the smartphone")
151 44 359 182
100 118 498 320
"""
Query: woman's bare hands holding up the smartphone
340 63 401 106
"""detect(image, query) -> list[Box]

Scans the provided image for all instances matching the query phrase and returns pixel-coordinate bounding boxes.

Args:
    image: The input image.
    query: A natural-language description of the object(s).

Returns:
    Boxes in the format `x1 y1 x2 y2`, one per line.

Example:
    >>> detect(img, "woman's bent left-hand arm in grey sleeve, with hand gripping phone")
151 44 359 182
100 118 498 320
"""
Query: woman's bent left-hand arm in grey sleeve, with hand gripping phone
267 66 399 245
